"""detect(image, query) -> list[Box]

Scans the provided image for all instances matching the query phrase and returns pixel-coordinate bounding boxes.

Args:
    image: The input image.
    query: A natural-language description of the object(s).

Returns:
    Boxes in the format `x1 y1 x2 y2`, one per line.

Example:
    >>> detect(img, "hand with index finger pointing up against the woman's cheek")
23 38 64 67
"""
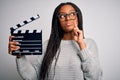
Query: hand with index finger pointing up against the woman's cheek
72 24 86 50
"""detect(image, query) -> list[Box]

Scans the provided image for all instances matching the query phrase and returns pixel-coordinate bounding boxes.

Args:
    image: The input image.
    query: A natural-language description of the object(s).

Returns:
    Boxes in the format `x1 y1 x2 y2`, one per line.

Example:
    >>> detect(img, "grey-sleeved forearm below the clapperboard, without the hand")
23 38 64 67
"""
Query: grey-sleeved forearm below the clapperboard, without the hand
16 56 37 80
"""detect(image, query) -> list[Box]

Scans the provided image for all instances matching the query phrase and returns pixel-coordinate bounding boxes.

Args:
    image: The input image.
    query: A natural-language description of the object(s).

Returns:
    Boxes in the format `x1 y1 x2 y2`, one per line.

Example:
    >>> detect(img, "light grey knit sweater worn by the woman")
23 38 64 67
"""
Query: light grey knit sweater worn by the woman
16 39 102 80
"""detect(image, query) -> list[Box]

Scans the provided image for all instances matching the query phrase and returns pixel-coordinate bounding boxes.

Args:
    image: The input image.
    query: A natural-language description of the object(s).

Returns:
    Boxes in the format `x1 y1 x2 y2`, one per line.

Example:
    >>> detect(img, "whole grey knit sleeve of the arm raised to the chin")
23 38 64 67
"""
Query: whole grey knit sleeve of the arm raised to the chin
78 39 102 80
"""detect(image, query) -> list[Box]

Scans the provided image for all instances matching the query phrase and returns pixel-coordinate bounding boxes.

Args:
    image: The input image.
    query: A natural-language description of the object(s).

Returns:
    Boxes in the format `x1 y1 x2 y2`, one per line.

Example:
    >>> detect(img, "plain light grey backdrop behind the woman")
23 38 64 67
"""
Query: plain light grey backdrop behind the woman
0 0 120 80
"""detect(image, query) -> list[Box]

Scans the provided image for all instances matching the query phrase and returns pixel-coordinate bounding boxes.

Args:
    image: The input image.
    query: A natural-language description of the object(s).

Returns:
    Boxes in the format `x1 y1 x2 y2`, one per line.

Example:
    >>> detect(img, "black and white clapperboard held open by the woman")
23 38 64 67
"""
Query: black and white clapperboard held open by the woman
10 15 42 55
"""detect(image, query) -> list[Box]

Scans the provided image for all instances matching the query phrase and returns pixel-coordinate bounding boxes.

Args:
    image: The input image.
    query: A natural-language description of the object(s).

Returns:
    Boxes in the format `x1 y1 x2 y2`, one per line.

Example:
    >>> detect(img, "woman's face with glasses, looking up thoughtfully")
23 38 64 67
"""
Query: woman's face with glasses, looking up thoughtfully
58 5 78 32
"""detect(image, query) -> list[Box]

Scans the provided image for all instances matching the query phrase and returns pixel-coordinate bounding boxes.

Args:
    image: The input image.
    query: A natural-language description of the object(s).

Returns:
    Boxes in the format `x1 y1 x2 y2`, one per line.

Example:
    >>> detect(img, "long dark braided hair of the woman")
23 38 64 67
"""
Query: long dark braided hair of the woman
39 2 83 80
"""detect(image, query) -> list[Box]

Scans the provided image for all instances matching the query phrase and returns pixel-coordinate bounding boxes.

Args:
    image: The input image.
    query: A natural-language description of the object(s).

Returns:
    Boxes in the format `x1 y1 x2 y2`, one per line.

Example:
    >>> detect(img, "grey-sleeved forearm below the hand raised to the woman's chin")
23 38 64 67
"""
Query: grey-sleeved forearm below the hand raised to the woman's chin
81 49 102 80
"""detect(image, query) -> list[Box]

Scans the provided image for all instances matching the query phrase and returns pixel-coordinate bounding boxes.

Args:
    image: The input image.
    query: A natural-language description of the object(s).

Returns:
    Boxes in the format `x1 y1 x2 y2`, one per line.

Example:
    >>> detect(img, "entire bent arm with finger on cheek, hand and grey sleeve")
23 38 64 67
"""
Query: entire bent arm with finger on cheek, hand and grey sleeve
72 24 102 80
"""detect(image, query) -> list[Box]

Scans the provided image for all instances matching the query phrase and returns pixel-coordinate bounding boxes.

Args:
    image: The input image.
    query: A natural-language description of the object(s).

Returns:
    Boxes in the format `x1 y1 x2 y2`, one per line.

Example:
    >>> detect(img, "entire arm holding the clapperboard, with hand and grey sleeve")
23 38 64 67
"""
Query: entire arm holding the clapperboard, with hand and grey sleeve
8 36 47 80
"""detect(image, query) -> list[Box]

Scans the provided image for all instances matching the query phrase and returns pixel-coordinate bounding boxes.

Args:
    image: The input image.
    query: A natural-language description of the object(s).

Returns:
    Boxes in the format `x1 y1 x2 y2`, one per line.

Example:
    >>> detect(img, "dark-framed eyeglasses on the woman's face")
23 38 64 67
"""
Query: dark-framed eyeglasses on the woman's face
58 12 78 21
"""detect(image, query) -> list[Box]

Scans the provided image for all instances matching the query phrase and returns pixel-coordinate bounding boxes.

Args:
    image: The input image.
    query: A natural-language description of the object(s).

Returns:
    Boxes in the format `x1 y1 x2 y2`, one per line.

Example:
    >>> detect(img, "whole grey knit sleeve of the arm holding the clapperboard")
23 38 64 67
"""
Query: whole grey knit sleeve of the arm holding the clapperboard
16 42 47 80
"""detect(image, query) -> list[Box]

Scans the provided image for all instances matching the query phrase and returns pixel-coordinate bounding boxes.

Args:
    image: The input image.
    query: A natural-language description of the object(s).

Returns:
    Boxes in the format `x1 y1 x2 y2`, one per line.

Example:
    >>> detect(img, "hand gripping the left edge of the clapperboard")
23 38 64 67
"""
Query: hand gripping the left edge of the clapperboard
8 36 19 55
